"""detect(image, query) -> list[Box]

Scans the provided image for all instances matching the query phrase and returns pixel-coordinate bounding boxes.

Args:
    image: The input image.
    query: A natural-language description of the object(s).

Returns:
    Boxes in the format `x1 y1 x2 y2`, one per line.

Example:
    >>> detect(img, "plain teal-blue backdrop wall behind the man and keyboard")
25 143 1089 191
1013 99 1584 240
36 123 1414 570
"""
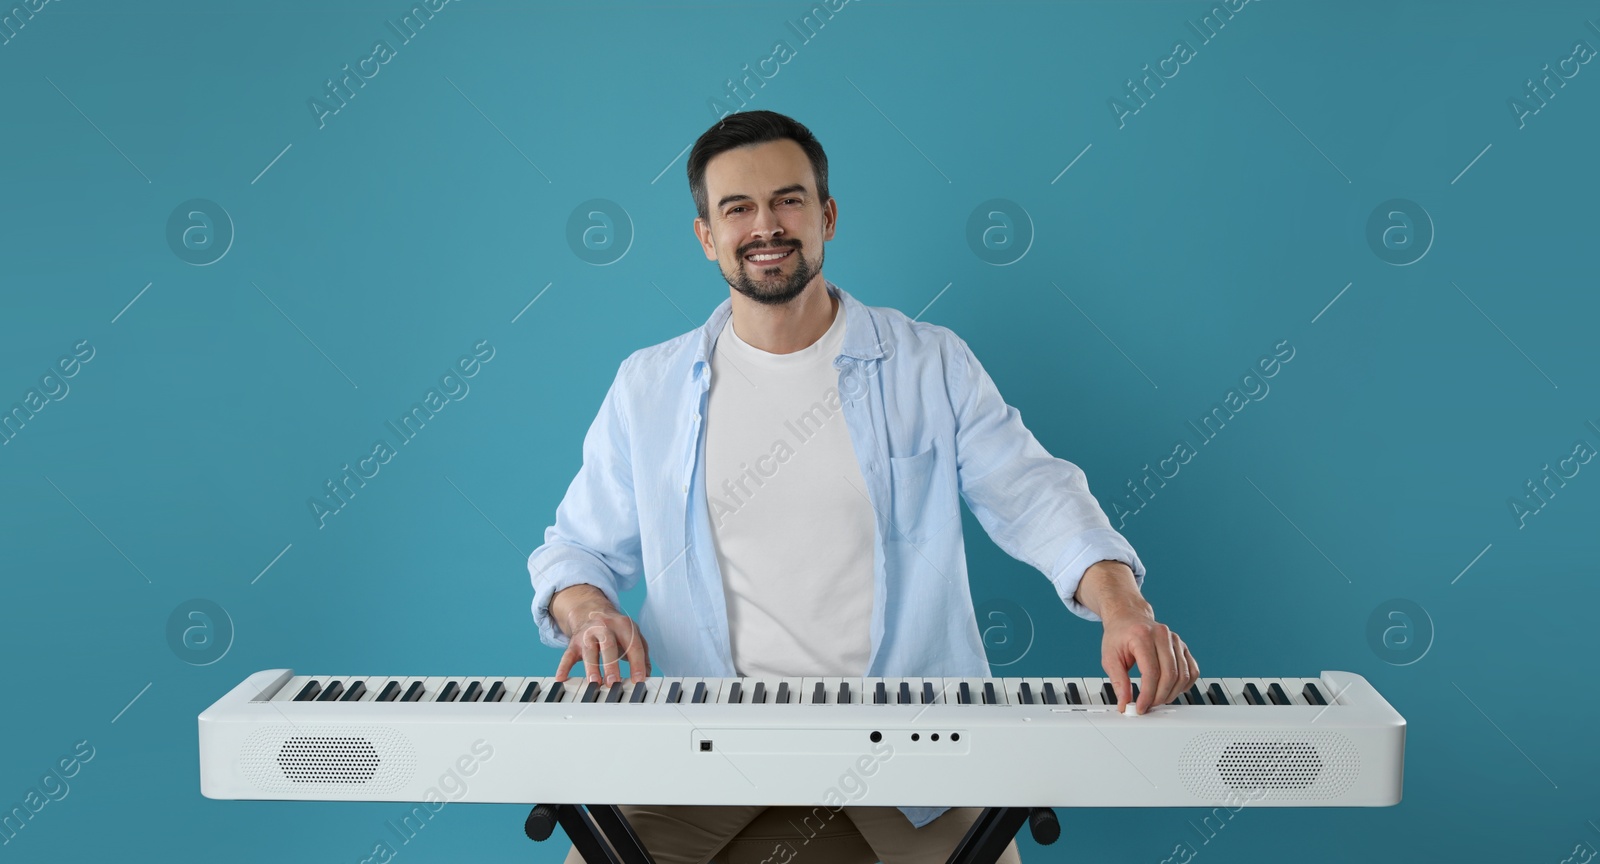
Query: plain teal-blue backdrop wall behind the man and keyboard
0 0 1600 864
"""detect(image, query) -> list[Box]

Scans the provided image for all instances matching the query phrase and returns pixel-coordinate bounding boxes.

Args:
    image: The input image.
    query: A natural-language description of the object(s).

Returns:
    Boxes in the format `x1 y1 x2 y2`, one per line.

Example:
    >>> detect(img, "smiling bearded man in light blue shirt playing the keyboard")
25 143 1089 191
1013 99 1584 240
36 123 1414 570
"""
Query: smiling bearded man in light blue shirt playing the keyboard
528 110 1200 862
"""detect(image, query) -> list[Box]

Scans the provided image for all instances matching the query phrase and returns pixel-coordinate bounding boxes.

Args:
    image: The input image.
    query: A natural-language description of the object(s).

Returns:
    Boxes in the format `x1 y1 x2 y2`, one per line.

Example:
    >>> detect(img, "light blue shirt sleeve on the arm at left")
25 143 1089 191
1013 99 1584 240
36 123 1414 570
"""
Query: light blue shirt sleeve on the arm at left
528 363 643 648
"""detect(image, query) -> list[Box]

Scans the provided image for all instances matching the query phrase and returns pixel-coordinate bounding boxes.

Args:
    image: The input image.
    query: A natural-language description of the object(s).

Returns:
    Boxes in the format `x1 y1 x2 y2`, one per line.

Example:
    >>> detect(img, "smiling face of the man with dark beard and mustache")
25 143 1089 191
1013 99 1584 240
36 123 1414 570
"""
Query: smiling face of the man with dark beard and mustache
694 138 838 306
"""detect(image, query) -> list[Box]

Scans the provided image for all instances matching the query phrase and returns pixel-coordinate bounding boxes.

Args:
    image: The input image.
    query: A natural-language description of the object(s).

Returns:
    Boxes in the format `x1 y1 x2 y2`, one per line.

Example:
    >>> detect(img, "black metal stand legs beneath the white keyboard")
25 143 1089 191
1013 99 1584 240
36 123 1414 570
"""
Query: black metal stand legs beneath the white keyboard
523 805 1061 864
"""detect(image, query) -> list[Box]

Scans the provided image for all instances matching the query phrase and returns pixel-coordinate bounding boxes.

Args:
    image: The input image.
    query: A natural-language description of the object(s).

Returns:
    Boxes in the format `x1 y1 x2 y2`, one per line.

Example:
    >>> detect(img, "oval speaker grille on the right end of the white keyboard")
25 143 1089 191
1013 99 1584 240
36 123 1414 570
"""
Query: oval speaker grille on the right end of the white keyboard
1178 731 1362 805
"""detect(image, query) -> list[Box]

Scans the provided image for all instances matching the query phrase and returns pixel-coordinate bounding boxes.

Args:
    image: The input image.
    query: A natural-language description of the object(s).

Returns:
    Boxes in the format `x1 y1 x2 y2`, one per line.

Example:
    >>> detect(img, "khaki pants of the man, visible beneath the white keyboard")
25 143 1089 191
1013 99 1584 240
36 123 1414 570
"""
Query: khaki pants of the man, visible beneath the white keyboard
566 805 1022 864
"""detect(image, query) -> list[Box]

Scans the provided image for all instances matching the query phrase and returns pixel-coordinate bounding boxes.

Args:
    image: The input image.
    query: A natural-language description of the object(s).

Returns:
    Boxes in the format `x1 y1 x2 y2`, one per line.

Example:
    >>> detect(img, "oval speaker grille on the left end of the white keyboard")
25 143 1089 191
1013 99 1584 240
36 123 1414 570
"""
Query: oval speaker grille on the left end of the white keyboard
238 725 416 795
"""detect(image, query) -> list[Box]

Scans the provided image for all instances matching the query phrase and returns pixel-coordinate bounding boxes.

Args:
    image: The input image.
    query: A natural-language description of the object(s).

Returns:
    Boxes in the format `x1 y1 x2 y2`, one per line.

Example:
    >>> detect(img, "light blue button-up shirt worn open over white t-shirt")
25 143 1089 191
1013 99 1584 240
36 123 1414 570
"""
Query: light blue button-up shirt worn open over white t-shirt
528 280 1144 827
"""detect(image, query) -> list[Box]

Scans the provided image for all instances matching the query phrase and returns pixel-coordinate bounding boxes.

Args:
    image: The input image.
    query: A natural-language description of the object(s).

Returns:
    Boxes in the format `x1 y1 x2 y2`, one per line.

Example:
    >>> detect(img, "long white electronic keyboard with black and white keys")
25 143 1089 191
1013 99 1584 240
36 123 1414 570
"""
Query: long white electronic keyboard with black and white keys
198 669 1405 808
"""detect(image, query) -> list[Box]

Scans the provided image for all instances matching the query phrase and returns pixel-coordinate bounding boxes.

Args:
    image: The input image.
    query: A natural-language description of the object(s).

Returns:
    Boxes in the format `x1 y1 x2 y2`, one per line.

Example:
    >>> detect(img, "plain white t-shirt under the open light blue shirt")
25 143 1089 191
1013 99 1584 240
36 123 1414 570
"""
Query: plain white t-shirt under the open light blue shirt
706 307 874 677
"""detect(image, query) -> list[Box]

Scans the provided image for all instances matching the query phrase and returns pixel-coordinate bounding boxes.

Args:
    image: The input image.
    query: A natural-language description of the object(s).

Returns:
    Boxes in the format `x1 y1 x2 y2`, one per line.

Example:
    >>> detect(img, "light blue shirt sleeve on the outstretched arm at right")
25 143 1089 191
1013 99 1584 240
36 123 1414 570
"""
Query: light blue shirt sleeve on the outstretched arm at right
944 333 1144 621
